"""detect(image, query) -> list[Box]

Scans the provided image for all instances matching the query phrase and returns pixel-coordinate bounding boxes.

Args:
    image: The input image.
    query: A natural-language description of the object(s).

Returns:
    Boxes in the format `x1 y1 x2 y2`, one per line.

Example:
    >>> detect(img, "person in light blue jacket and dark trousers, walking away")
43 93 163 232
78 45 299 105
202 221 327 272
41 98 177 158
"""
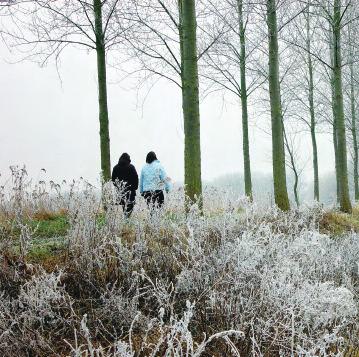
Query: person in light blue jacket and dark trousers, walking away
140 151 171 208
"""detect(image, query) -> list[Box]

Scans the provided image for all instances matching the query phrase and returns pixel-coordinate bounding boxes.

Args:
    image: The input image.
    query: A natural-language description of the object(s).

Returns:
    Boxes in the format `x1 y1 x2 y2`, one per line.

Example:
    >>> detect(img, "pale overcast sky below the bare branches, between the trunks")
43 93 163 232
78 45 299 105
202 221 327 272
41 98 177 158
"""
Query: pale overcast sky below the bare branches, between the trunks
0 44 334 188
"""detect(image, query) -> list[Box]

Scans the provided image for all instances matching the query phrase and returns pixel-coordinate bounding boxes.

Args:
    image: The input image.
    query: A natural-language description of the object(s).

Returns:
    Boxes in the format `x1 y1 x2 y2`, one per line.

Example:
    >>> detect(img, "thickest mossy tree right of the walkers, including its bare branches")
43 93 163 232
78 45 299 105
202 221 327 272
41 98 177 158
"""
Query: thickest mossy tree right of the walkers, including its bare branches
126 0 216 204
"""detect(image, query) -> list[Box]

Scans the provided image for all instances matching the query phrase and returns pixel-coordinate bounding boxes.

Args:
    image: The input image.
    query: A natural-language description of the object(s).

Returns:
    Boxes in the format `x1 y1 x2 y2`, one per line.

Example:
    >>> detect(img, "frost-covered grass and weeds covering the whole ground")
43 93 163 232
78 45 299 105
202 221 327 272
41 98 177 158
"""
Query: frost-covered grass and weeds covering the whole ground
0 169 359 357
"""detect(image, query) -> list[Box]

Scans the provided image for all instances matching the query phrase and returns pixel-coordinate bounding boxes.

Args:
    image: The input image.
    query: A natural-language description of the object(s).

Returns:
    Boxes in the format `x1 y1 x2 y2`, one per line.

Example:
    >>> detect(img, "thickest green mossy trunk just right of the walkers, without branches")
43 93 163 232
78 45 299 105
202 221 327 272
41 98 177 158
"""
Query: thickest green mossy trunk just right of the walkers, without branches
179 0 202 206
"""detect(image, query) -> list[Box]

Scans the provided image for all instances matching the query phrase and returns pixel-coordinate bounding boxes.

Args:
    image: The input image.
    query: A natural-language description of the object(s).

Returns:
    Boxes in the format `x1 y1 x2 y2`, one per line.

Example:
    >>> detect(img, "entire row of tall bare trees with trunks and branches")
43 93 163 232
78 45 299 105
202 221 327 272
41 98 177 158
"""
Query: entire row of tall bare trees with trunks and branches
1 0 359 212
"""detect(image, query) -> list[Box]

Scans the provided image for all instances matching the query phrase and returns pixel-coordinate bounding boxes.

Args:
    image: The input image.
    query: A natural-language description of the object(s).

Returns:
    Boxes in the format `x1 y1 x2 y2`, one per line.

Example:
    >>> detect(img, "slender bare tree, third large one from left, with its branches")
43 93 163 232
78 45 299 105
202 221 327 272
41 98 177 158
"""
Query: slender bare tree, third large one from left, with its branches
201 0 266 199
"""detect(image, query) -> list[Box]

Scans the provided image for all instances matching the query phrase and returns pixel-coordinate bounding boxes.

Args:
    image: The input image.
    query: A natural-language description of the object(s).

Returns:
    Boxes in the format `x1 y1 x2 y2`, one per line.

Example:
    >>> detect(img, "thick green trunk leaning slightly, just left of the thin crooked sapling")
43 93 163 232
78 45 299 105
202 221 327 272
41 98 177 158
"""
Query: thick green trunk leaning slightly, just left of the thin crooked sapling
267 0 290 211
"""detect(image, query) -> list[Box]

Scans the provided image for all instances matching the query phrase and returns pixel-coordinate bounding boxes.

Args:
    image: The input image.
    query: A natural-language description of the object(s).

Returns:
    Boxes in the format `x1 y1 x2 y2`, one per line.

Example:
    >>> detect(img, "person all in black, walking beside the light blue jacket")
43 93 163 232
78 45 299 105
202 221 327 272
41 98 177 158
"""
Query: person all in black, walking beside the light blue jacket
112 153 138 217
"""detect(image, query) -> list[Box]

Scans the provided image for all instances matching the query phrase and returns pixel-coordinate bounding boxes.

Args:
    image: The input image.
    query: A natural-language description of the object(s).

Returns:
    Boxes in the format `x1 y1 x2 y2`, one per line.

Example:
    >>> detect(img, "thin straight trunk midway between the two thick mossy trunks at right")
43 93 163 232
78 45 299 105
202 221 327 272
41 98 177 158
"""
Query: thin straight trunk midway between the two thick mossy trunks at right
306 4 319 201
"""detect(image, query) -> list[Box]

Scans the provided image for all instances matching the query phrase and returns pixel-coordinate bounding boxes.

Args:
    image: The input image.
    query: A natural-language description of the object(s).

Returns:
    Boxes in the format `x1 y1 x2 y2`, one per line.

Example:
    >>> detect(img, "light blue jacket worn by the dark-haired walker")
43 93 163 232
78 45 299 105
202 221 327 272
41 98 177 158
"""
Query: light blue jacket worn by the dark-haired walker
140 160 171 193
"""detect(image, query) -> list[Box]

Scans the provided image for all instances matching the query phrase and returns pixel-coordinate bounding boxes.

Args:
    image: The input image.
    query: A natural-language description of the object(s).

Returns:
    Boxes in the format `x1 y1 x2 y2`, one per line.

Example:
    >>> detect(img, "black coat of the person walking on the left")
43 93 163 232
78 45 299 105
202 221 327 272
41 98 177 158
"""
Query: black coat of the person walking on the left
112 159 138 200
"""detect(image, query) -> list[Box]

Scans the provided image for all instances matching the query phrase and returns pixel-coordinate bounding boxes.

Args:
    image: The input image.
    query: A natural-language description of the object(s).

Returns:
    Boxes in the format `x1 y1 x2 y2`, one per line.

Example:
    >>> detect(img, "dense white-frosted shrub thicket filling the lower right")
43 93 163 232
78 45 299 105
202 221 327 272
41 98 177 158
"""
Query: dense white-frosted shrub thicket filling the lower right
177 210 358 355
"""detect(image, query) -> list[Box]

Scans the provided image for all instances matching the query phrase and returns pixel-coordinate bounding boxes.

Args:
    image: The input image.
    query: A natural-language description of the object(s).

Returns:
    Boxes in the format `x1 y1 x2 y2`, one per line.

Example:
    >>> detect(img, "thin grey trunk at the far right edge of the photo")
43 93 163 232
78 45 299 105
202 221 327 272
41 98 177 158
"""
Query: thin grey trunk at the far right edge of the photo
349 26 359 201
